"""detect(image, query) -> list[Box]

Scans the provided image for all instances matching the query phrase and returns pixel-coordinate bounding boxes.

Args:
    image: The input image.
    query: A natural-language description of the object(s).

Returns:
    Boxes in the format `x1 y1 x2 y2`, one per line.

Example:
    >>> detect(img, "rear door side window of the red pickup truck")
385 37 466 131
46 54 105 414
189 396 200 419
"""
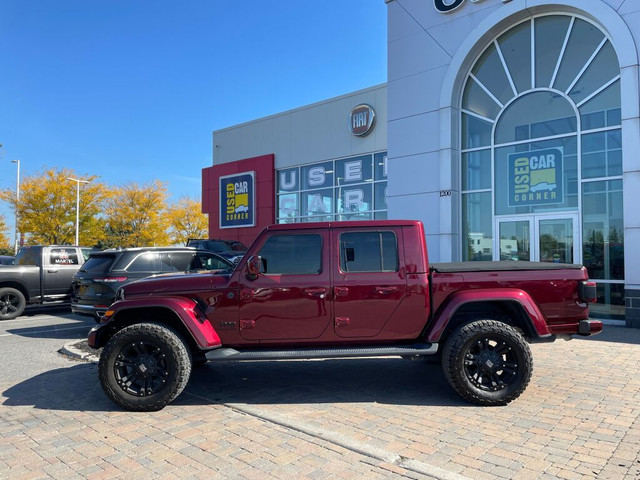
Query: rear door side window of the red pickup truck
340 232 398 272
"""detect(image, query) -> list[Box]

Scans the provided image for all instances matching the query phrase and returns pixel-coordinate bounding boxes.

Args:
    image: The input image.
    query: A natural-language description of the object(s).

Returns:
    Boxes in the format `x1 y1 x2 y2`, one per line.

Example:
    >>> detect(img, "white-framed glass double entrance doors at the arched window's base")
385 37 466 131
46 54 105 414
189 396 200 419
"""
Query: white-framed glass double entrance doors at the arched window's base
494 214 581 263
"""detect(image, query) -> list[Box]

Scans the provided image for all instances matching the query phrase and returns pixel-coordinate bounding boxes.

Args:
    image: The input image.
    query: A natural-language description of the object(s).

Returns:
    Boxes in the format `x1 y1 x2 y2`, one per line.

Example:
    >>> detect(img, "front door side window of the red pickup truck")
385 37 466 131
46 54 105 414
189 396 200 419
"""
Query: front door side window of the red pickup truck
258 234 322 275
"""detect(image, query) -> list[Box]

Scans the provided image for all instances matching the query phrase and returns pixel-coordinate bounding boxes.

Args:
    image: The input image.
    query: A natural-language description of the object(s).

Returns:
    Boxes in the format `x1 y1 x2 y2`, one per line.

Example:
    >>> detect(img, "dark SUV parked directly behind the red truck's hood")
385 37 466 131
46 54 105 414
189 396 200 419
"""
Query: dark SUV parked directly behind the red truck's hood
71 247 233 322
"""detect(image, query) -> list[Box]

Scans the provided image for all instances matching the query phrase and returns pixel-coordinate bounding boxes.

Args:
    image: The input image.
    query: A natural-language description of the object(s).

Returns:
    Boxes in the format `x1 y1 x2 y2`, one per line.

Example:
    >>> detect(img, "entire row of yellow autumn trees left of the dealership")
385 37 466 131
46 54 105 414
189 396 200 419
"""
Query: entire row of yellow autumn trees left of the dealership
0 169 208 249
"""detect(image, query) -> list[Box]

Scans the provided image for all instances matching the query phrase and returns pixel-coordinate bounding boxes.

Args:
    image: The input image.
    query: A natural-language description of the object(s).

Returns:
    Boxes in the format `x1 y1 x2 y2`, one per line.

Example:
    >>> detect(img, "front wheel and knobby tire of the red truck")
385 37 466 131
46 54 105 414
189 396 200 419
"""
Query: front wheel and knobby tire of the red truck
98 323 192 412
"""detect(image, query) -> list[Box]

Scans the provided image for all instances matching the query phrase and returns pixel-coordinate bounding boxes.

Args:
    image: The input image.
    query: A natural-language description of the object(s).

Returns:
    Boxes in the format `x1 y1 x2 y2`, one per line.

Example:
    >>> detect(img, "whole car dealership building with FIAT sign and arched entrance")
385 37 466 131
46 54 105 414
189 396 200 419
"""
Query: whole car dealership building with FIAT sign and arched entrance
202 0 640 327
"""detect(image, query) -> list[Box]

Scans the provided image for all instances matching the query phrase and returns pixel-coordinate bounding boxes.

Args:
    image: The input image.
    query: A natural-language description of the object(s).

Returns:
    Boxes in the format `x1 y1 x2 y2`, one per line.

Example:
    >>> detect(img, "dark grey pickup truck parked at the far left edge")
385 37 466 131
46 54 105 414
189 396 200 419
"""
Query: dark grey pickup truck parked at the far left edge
0 245 91 320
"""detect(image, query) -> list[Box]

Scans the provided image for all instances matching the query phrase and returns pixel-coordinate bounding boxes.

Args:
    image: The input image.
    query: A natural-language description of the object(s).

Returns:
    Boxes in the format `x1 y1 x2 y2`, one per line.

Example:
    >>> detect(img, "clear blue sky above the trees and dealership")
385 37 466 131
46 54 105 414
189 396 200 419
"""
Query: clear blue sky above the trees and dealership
0 0 387 244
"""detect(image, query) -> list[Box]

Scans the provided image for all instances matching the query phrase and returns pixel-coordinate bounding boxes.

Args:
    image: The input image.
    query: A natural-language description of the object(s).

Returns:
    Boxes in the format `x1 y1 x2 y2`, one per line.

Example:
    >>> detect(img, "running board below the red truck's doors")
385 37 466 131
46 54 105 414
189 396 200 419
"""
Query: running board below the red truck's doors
205 343 438 361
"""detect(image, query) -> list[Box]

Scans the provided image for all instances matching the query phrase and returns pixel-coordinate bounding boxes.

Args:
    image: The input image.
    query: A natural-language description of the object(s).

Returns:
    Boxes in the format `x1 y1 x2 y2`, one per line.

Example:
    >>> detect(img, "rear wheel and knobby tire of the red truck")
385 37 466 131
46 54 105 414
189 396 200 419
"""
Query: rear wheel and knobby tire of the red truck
442 320 533 405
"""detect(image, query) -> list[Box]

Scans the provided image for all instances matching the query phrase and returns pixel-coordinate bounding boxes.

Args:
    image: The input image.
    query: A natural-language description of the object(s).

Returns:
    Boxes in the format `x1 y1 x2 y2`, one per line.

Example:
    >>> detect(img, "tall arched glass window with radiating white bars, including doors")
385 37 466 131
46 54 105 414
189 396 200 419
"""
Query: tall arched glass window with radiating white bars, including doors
460 15 624 315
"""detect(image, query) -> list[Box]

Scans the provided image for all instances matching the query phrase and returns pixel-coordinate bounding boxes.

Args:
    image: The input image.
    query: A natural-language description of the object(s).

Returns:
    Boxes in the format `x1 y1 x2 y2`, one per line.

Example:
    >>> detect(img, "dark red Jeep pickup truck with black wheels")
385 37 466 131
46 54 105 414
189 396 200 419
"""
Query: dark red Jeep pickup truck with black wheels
89 220 602 411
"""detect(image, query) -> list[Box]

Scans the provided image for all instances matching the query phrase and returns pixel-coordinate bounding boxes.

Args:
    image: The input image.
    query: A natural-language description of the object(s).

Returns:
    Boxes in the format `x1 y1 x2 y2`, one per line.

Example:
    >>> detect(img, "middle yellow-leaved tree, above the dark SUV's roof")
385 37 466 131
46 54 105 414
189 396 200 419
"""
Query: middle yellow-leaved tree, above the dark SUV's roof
100 180 168 248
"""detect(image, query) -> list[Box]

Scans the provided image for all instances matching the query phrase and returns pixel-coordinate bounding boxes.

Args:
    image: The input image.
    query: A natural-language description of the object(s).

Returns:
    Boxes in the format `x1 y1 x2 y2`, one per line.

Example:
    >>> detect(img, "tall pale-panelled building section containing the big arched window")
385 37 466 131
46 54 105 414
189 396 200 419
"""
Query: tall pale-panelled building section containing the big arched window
387 0 640 326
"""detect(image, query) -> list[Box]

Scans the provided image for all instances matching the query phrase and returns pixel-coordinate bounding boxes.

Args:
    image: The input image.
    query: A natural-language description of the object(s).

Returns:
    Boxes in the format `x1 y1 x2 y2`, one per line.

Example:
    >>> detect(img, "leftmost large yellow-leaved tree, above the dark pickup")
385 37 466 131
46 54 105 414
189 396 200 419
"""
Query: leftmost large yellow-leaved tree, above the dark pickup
0 169 107 245
